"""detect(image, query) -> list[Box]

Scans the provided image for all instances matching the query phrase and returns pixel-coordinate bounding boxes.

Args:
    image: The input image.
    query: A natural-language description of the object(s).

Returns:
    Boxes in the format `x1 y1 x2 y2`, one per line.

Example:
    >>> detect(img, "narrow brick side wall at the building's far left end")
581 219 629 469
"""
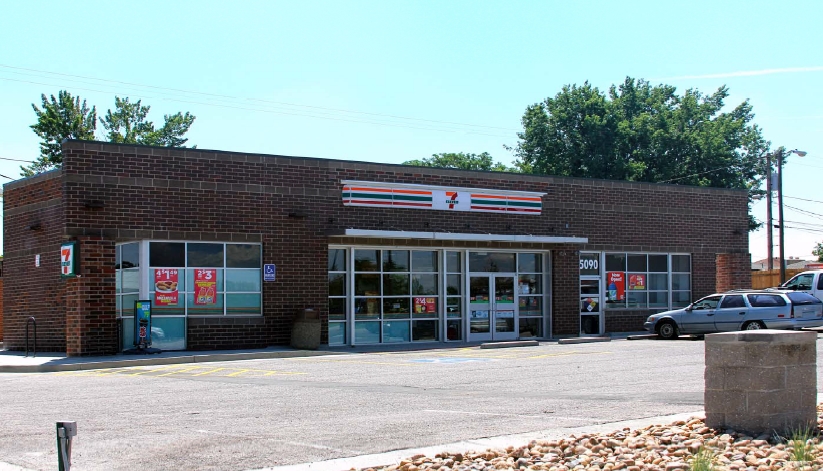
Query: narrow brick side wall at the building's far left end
3 171 66 352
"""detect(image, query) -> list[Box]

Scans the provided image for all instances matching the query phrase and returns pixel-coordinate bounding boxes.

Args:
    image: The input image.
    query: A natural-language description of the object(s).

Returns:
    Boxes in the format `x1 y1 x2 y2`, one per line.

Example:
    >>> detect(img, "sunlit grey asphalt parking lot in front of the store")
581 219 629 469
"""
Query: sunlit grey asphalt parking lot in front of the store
0 336 823 471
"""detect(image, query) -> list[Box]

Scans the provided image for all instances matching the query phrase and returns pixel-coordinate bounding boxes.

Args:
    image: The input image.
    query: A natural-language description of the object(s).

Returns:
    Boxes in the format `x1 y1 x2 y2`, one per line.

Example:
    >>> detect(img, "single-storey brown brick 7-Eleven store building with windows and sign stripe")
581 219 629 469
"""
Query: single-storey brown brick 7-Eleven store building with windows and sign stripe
3 141 751 355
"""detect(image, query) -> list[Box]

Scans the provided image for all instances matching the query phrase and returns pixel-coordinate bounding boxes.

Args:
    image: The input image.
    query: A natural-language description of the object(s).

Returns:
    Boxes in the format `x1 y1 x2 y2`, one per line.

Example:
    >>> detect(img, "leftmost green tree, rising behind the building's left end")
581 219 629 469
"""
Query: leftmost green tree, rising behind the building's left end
20 90 97 177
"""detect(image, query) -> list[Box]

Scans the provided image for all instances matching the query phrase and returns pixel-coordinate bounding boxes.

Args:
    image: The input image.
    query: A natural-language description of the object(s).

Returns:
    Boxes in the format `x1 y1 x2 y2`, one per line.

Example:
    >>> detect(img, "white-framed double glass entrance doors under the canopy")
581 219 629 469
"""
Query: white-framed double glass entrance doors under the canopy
469 273 517 341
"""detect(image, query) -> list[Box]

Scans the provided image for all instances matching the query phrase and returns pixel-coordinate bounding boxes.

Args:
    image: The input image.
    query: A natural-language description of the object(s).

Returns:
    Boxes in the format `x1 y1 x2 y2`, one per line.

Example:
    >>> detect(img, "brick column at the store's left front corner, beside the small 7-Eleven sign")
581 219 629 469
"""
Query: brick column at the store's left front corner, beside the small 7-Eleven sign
66 237 119 356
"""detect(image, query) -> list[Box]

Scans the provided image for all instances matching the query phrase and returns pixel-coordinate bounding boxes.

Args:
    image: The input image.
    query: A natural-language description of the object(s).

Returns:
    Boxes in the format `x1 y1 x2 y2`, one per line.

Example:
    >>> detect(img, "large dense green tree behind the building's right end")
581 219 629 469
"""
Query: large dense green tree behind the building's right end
513 77 770 228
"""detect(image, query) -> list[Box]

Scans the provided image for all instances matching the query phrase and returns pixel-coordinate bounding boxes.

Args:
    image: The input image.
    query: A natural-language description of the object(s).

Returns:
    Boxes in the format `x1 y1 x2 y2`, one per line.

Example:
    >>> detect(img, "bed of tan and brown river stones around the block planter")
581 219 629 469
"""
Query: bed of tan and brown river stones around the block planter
363 404 823 471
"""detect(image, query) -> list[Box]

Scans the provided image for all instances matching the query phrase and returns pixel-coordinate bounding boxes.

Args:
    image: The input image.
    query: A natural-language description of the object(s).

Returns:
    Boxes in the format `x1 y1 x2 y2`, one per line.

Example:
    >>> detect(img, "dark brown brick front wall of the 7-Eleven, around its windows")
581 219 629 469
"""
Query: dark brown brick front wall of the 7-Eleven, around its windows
7 141 748 349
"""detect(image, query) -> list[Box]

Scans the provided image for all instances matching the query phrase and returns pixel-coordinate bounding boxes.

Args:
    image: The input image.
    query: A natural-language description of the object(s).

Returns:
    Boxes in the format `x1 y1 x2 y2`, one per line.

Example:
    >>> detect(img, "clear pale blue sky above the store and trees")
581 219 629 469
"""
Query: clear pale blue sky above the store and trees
0 0 823 259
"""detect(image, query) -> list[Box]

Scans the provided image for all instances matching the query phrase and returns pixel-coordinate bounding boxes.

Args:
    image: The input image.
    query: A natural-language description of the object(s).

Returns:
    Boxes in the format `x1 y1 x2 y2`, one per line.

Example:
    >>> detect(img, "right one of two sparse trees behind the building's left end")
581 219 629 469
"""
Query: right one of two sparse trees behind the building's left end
100 96 195 147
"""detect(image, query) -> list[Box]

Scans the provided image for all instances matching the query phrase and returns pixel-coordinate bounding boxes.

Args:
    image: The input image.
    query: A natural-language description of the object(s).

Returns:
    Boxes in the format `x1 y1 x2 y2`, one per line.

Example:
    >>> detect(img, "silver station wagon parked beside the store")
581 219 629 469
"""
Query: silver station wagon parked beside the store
643 290 823 339
